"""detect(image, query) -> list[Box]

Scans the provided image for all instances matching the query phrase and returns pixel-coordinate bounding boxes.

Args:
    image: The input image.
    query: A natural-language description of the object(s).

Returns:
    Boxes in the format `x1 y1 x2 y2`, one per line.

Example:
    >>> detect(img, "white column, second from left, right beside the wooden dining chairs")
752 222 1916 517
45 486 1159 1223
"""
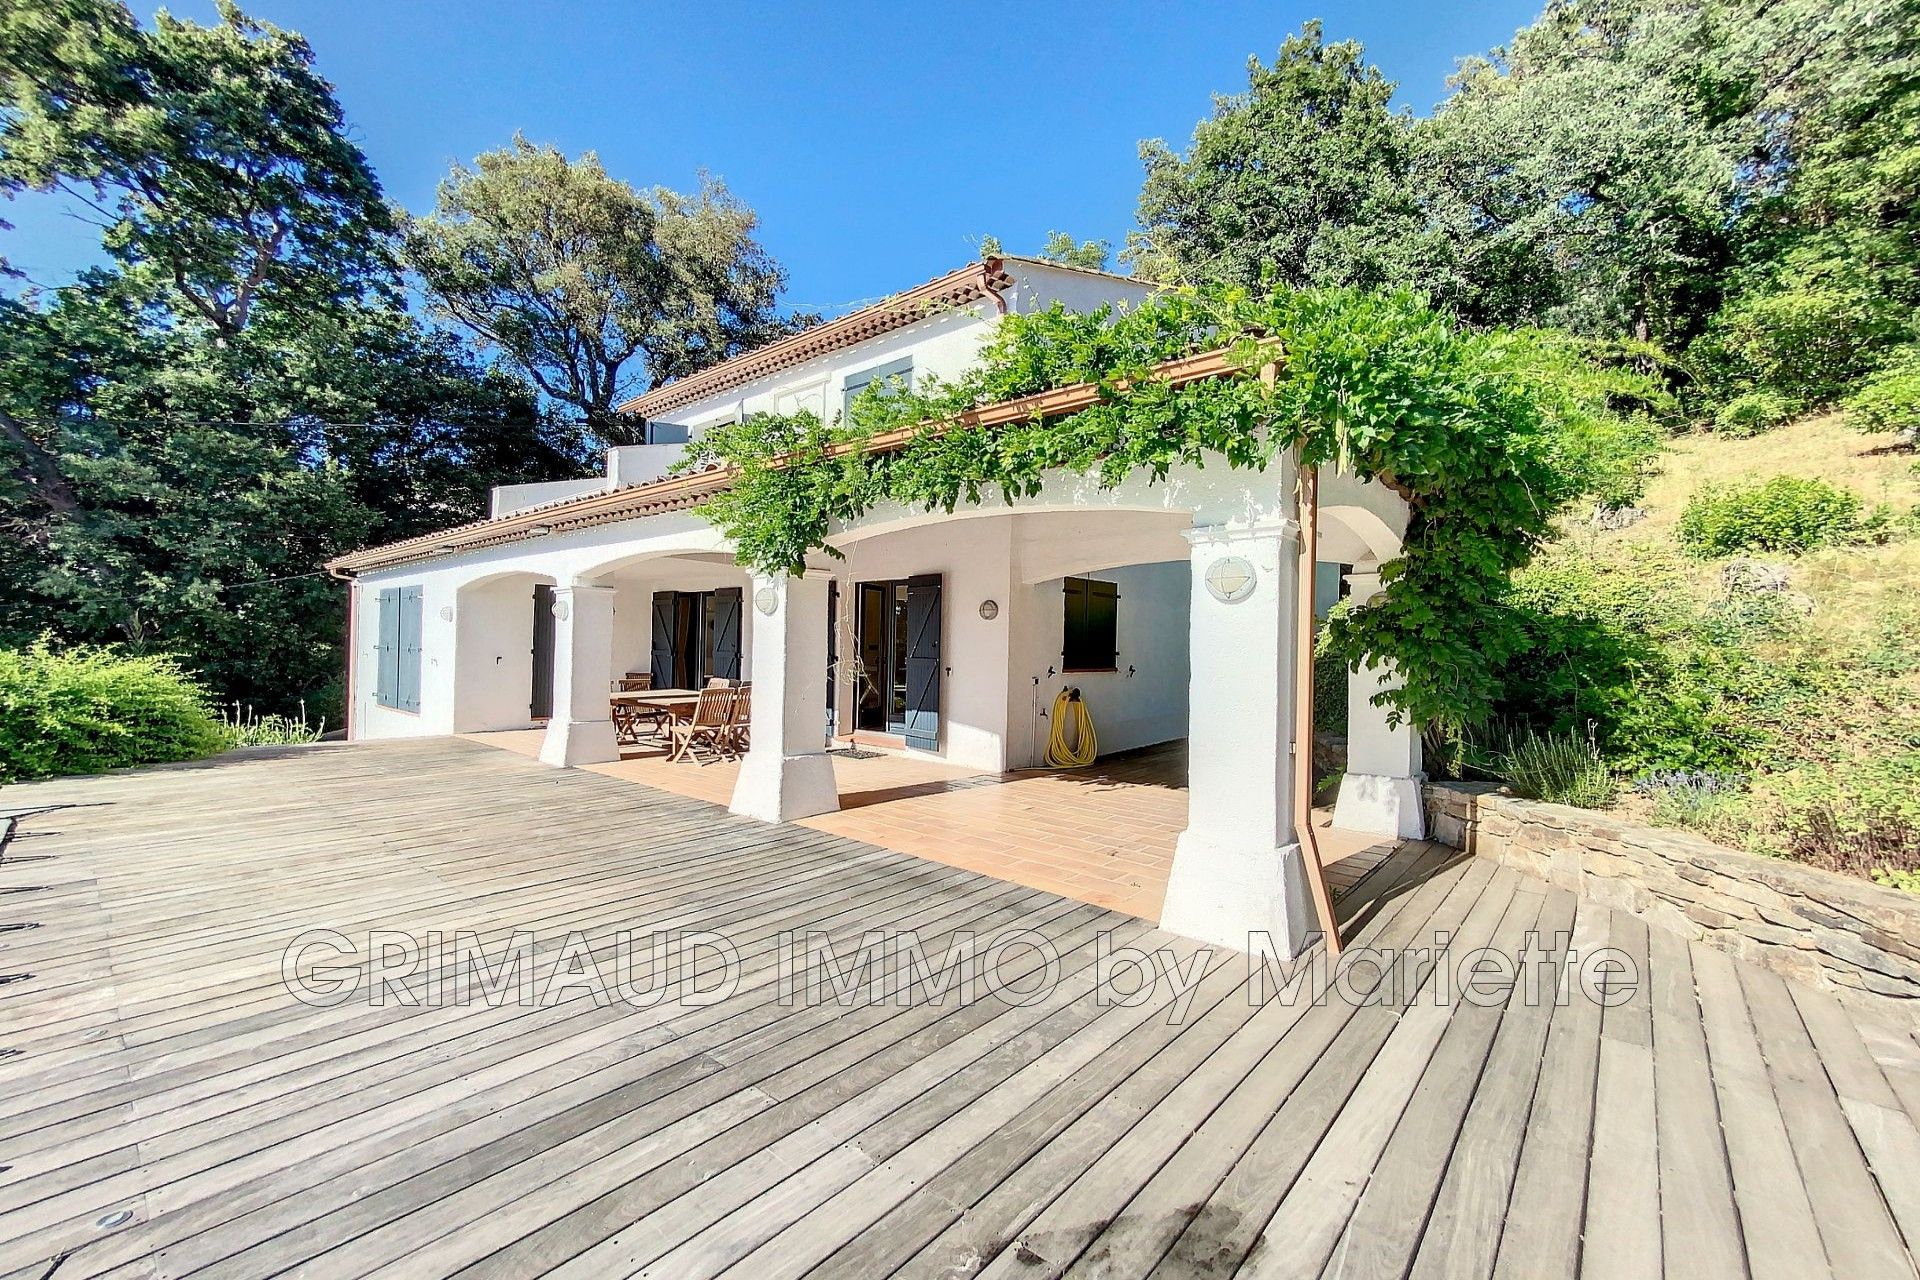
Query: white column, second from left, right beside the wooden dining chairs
732 574 839 821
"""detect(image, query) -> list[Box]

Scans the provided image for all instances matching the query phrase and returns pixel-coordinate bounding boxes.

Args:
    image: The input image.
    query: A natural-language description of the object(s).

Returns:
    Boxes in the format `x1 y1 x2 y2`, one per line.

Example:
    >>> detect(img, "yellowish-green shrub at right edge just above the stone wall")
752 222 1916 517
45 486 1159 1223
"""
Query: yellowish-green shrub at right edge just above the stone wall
1774 750 1920 879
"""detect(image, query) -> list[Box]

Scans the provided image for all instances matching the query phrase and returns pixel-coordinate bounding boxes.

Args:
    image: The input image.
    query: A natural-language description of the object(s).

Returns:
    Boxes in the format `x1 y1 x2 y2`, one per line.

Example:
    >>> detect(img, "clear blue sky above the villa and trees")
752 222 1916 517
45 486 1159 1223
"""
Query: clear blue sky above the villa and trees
0 0 1540 315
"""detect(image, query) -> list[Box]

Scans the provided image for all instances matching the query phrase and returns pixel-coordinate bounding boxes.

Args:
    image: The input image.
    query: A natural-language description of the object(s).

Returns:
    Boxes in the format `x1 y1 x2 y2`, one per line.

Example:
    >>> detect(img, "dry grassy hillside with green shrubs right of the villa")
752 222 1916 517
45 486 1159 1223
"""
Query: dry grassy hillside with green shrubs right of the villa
1461 415 1920 889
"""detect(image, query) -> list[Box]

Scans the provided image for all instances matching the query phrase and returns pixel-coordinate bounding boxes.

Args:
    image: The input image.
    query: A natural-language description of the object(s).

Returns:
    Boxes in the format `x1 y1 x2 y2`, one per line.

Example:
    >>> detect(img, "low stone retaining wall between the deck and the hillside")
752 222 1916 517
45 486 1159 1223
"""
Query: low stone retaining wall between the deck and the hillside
1425 783 1920 1017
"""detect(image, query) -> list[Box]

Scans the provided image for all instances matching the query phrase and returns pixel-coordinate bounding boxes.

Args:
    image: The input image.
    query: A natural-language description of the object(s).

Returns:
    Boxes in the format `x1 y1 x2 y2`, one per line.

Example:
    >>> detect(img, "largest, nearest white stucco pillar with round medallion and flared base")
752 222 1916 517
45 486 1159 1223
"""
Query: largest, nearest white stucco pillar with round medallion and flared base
1160 520 1317 956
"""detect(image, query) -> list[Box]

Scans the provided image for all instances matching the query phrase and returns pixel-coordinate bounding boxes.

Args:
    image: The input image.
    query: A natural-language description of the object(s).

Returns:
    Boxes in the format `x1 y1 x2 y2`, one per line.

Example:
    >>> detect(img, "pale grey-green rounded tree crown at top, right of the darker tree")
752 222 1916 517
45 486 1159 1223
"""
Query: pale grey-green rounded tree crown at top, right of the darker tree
1415 0 1755 344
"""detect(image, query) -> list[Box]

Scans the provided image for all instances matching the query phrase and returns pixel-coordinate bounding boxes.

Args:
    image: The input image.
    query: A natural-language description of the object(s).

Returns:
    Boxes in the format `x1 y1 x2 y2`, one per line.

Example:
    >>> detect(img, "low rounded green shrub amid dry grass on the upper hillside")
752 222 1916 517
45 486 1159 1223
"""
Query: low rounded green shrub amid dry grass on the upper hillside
1680 476 1889 558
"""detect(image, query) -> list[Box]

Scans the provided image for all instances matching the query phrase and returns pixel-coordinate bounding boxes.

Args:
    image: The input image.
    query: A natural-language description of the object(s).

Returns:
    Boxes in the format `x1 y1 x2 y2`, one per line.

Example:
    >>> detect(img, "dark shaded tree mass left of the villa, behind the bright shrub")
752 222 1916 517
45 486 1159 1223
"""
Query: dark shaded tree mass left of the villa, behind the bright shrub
0 273 578 710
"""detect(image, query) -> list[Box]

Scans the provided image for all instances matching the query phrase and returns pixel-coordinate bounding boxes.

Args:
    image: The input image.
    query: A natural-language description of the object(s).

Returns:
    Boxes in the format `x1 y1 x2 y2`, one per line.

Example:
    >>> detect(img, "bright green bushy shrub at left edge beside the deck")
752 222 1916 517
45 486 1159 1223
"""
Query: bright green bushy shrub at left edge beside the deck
0 639 228 783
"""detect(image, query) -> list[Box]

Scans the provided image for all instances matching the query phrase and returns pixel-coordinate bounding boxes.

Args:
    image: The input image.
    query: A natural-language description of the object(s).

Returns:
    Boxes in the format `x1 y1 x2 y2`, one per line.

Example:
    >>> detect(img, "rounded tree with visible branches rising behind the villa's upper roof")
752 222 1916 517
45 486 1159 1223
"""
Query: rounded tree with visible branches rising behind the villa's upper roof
405 136 804 443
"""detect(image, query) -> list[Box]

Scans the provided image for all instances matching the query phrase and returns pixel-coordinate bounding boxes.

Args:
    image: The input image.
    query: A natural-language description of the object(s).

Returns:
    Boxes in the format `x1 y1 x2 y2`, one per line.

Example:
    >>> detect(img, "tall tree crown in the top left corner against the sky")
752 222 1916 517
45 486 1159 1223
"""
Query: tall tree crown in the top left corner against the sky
0 0 390 338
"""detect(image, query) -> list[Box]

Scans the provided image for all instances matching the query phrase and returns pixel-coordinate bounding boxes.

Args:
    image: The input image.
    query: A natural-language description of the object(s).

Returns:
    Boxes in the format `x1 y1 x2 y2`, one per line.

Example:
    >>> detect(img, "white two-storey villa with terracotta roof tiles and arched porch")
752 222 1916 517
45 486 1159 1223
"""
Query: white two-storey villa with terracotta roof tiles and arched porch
330 257 1421 952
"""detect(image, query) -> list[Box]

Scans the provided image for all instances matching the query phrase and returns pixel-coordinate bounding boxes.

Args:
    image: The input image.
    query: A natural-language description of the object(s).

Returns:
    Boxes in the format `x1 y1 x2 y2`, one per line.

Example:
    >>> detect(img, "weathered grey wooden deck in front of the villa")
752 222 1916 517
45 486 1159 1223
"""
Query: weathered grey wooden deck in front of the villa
0 741 1920 1280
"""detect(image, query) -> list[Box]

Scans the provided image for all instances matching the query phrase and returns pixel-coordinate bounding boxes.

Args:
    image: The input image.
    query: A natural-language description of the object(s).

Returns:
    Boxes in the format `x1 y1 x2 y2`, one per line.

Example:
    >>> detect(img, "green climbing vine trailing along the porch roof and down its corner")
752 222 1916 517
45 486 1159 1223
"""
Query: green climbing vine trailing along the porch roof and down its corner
684 290 1663 725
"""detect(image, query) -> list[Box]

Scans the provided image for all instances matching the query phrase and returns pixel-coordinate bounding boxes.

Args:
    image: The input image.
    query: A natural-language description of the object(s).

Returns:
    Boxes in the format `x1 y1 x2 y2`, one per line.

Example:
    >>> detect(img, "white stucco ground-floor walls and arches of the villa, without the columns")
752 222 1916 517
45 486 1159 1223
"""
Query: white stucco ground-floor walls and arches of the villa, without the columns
351 441 1404 782
